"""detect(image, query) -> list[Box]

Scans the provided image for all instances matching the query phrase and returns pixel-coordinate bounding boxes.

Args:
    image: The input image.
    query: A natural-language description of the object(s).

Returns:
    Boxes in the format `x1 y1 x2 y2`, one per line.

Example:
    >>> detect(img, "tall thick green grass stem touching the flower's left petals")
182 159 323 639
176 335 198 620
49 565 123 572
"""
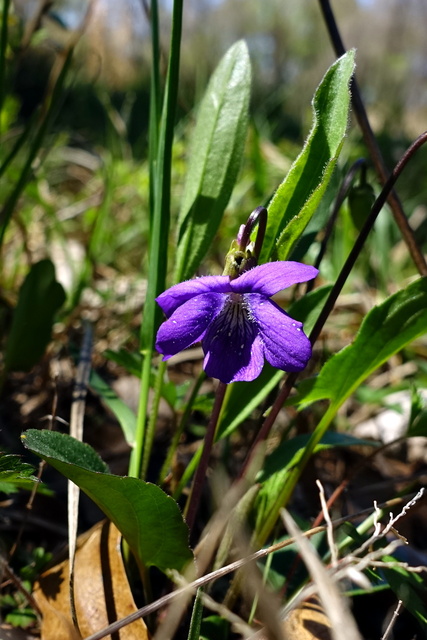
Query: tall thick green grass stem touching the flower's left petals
129 0 183 477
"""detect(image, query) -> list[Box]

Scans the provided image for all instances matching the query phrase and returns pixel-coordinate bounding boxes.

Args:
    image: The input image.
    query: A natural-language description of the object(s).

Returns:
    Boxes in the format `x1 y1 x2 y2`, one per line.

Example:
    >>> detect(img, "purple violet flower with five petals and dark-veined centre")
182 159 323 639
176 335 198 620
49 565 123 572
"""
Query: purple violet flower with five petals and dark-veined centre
156 261 318 383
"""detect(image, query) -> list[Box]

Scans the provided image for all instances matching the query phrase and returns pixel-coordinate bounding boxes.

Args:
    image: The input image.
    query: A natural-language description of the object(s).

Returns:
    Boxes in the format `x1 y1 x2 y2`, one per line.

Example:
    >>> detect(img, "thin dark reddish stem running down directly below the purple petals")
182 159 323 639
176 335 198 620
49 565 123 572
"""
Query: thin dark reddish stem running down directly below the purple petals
185 382 227 533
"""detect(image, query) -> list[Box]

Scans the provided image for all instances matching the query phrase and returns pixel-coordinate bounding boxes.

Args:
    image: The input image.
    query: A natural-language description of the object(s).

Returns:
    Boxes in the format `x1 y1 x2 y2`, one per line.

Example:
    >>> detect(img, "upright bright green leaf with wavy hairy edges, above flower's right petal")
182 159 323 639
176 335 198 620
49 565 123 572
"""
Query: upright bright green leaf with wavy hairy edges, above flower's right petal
260 50 355 262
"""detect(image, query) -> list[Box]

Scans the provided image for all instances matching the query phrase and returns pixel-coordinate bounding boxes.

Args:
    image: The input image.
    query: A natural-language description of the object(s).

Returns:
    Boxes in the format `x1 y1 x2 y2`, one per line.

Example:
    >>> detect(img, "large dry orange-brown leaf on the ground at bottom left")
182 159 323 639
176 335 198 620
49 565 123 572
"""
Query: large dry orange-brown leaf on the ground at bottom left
34 521 149 640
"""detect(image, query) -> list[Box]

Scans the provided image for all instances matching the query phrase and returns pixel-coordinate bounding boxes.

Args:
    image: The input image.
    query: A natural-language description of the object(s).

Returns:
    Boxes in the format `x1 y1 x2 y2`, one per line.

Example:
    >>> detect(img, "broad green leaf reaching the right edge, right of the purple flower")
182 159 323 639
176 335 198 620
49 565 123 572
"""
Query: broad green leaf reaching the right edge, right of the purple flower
296 277 427 407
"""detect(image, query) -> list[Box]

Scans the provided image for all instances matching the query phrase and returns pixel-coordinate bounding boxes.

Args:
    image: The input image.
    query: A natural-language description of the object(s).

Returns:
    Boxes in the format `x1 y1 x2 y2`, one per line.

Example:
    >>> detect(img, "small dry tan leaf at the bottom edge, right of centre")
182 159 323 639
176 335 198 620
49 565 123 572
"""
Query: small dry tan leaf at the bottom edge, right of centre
283 602 332 640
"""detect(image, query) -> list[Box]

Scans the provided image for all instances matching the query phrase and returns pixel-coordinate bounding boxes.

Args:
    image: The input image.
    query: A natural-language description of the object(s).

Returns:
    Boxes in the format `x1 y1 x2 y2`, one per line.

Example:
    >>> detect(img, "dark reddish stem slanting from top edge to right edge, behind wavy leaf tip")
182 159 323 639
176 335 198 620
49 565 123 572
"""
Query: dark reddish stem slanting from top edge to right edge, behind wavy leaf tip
319 0 427 276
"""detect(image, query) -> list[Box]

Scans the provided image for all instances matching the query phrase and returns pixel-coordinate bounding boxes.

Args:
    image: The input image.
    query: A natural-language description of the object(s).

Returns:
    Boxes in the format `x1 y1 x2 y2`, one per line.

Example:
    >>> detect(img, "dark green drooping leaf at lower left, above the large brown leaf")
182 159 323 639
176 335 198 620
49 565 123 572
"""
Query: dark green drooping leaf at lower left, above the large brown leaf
22 429 193 571
